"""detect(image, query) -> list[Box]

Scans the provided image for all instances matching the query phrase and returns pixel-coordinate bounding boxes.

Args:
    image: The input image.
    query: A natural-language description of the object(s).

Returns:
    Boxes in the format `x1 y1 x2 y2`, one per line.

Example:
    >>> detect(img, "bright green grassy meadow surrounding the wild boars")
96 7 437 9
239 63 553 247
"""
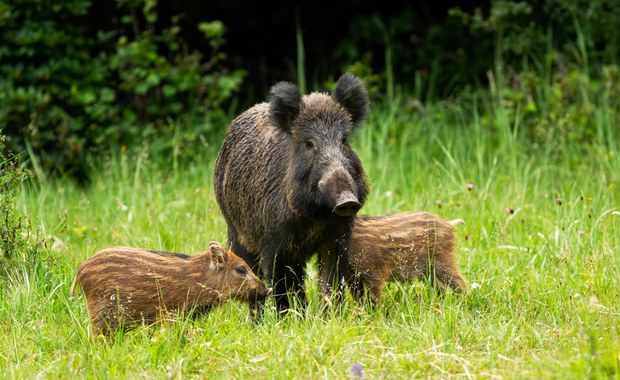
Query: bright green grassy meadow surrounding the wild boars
0 89 620 379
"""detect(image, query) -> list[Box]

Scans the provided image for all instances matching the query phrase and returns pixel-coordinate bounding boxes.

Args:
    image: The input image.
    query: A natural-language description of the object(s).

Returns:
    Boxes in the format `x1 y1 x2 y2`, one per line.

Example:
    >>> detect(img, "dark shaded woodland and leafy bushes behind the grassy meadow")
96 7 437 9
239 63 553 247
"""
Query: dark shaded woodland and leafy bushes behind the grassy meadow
0 0 620 179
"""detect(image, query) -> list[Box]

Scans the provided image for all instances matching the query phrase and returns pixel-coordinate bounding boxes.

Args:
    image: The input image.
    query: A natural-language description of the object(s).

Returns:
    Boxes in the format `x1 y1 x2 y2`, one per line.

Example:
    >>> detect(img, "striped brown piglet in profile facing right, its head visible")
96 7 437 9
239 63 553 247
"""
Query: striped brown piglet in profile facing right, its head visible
71 242 270 336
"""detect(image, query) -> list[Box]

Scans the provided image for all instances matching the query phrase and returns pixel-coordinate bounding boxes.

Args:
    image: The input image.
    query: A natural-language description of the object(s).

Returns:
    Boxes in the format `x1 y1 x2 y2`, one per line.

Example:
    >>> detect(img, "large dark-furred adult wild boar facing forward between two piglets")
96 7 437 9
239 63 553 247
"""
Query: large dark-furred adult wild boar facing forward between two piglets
214 74 369 312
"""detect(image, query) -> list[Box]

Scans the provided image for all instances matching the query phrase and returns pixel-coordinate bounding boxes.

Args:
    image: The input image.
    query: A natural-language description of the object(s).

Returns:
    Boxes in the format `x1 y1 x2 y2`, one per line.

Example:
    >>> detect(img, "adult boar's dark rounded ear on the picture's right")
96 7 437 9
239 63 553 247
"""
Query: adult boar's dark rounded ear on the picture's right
333 73 370 126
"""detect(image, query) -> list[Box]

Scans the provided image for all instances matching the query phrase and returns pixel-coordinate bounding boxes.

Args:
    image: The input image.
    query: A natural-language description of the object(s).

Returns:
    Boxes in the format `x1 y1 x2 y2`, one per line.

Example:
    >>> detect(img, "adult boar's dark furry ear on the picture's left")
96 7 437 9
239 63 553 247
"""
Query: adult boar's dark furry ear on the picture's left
269 82 301 132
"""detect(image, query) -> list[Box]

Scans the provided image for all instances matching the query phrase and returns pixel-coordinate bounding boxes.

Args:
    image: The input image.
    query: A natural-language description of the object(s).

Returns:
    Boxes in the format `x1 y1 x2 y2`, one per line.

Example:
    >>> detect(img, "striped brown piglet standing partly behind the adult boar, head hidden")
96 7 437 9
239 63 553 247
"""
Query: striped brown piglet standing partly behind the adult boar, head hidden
348 212 467 304
